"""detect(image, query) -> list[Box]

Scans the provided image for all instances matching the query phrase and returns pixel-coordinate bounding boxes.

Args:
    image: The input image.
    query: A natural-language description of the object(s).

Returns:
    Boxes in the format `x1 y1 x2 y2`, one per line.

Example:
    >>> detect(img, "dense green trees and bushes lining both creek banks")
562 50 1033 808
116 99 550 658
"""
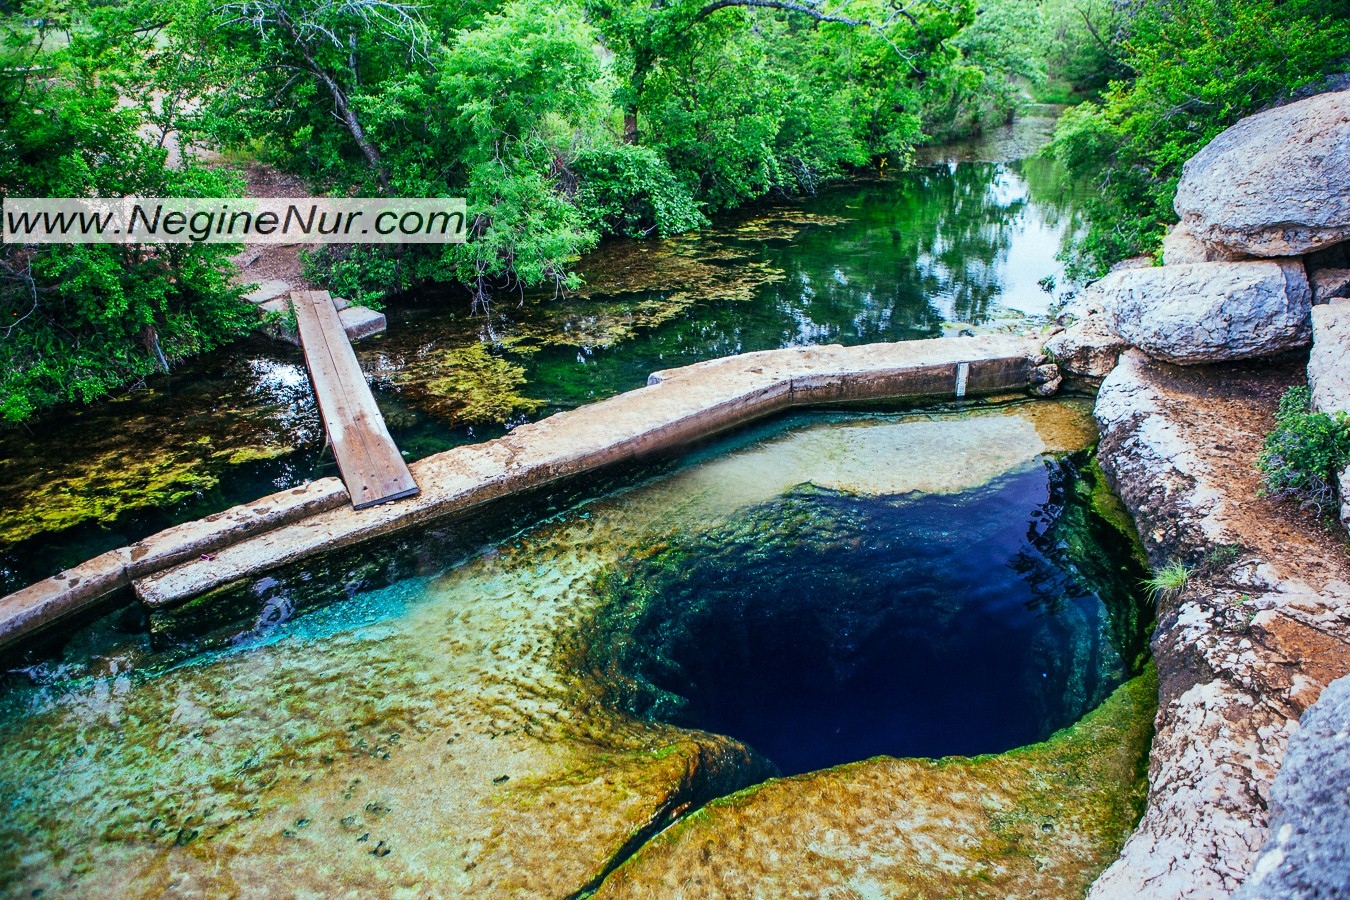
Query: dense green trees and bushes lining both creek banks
0 0 1350 421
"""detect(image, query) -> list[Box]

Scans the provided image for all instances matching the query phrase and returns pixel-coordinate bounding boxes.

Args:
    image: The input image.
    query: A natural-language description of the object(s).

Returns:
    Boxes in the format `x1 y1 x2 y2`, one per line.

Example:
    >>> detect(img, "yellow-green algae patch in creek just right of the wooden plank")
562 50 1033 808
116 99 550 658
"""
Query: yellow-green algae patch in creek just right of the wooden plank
397 343 544 425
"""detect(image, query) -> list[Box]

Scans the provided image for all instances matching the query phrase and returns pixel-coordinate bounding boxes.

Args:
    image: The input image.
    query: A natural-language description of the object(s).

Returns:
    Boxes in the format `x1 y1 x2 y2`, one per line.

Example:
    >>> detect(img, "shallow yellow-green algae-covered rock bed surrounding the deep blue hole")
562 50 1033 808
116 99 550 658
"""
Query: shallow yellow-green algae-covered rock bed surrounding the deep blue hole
0 401 1154 897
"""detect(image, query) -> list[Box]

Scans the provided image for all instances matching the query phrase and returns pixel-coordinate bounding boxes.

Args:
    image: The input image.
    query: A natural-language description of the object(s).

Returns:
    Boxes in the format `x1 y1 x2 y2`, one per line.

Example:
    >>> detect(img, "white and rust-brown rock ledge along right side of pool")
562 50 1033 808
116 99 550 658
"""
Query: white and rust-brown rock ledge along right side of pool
1089 352 1350 900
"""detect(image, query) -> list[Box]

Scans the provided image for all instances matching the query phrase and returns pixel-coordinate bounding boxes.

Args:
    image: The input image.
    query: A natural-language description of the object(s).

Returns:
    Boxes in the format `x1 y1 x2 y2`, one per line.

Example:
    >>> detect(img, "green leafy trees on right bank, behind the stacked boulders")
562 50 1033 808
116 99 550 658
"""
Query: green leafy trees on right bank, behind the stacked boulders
1054 0 1350 275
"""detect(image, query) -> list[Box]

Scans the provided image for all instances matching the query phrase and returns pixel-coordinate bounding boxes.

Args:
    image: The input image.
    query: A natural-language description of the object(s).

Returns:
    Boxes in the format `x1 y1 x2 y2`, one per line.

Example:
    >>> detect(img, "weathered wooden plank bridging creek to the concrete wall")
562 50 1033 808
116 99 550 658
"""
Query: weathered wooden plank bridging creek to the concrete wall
290 290 419 509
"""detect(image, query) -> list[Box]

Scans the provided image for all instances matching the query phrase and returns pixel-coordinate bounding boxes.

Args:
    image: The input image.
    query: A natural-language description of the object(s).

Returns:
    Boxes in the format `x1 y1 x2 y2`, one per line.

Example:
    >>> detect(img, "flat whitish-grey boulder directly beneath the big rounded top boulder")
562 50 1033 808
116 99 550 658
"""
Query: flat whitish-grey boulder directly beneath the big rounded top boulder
1098 260 1312 366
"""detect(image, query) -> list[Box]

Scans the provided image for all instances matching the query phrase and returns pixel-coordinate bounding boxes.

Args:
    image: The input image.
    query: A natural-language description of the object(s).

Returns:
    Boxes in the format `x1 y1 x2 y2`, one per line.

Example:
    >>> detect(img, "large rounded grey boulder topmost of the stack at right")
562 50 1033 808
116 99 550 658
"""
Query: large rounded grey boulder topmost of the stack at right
1175 90 1350 256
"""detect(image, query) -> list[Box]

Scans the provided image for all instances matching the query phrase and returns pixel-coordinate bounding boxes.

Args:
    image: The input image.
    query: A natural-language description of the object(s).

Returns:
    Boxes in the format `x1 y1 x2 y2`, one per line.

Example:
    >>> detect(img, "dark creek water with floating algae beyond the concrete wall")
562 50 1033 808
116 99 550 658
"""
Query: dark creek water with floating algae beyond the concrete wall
0 149 1076 594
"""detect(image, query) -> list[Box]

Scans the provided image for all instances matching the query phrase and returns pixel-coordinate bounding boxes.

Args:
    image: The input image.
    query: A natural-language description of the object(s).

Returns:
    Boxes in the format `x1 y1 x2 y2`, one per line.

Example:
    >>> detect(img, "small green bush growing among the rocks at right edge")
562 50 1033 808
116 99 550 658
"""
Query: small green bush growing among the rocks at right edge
1257 386 1350 513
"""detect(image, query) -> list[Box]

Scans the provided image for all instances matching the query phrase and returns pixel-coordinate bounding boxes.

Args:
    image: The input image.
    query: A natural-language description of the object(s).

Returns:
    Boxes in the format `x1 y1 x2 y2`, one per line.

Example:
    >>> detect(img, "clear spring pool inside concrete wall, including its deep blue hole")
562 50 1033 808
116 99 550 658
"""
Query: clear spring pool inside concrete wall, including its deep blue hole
0 401 1146 896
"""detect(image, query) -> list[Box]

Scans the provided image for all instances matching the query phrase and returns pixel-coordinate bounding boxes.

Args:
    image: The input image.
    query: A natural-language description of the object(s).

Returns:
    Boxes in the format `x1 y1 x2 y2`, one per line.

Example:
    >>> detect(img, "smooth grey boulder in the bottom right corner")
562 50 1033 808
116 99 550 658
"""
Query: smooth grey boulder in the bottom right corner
1235 679 1350 900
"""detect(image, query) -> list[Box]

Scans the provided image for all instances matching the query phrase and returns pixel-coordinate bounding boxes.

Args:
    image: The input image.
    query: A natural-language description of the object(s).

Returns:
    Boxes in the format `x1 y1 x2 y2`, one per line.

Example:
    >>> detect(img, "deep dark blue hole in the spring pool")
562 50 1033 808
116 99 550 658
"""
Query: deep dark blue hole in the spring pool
591 460 1137 775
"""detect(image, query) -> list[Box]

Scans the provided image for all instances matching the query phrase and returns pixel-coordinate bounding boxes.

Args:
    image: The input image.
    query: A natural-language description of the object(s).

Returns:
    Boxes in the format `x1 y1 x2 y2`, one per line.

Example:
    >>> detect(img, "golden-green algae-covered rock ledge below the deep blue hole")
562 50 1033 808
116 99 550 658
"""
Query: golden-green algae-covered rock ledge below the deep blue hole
595 664 1158 899
